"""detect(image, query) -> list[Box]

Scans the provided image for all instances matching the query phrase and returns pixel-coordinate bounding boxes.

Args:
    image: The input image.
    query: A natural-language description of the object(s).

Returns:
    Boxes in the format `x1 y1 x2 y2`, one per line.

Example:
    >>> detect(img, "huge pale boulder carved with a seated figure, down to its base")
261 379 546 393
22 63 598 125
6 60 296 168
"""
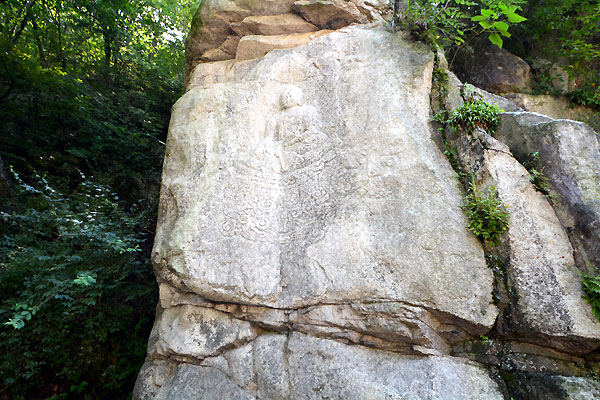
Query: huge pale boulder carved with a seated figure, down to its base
136 27 500 399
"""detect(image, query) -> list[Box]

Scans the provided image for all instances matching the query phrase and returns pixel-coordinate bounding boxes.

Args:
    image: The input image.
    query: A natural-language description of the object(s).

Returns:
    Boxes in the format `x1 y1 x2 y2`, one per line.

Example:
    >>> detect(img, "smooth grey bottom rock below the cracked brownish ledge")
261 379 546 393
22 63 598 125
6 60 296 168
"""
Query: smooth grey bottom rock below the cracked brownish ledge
135 333 503 400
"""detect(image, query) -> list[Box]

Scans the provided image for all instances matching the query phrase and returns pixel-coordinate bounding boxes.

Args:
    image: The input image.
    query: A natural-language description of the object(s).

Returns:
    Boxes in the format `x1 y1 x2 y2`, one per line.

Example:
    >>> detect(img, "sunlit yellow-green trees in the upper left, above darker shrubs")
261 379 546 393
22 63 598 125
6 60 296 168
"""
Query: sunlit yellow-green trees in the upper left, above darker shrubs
0 0 197 201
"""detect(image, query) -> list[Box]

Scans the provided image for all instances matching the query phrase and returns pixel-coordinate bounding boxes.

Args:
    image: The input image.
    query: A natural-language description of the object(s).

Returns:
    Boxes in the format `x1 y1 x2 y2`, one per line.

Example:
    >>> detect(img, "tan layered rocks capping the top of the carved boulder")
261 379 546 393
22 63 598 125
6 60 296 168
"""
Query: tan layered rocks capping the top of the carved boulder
185 0 391 81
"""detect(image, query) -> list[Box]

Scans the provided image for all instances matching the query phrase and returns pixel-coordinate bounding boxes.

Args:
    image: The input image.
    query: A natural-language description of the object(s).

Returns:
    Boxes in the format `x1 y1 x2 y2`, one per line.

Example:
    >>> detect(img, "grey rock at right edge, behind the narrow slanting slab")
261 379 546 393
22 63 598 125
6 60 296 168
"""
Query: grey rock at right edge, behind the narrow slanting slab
497 113 600 268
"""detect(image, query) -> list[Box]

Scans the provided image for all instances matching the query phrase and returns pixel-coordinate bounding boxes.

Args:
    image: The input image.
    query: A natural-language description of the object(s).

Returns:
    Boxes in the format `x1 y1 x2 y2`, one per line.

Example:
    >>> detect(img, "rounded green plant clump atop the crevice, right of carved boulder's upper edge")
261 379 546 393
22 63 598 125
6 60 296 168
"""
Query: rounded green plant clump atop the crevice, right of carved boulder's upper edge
446 98 502 135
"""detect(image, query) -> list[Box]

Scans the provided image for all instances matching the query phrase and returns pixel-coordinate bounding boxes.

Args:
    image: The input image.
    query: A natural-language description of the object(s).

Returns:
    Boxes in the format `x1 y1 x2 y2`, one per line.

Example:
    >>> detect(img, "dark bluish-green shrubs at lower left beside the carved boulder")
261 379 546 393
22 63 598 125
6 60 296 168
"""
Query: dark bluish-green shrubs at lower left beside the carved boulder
0 174 156 398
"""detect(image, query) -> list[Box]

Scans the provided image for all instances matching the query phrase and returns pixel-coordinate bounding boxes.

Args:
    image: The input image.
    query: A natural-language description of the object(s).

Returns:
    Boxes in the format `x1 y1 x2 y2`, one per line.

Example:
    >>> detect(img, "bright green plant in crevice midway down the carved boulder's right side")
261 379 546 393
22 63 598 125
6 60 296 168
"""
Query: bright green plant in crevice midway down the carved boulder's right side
463 182 508 247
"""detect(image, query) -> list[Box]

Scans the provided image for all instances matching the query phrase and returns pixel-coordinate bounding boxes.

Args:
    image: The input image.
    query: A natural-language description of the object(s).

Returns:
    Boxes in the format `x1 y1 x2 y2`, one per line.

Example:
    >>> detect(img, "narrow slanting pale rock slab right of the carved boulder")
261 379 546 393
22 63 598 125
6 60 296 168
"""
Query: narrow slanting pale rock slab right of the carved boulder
448 127 600 354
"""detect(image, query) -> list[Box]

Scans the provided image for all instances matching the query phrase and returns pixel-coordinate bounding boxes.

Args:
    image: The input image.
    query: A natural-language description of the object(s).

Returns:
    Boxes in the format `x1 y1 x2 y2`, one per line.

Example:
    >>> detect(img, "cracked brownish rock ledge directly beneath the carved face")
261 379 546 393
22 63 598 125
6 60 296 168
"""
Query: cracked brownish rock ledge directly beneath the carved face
157 284 496 358
